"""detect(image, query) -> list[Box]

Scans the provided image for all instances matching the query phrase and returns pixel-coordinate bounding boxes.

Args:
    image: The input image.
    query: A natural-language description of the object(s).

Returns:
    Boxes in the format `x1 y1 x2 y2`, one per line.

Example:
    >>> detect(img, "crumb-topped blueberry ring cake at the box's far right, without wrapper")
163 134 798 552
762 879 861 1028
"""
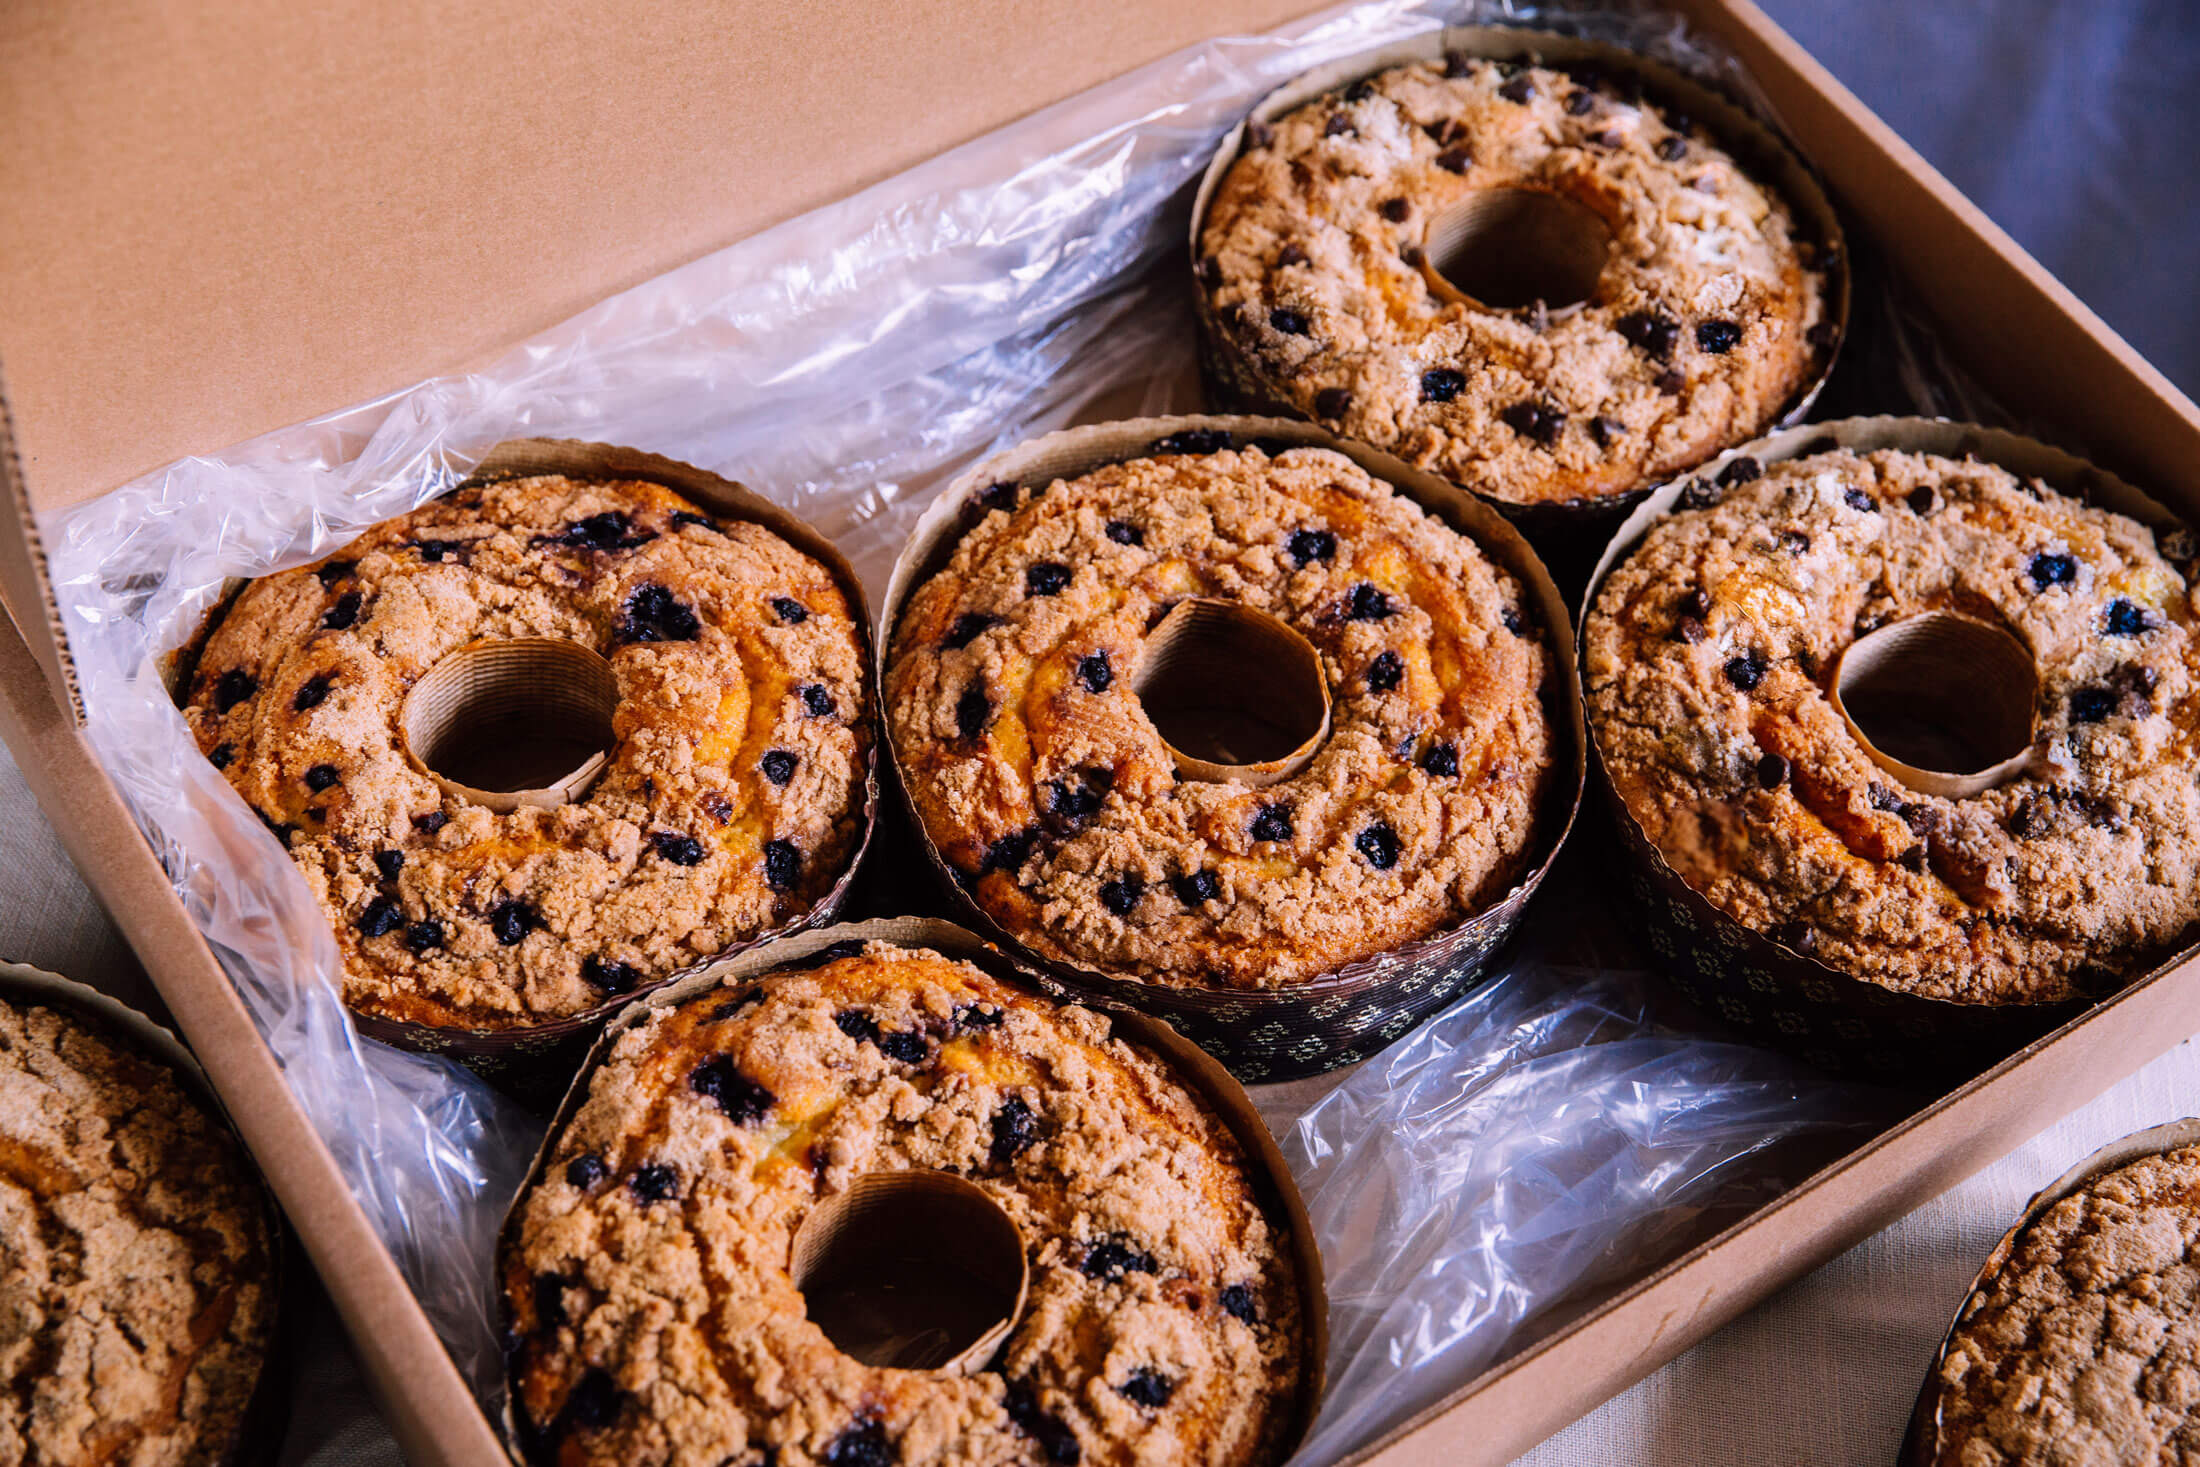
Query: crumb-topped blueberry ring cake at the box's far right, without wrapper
1584 451 2200 1003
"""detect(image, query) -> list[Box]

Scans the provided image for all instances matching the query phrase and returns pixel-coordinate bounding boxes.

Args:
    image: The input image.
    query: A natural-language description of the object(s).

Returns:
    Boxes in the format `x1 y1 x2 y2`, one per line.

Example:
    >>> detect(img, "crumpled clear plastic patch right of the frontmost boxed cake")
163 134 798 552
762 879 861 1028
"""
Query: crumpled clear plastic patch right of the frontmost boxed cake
1267 849 1901 1467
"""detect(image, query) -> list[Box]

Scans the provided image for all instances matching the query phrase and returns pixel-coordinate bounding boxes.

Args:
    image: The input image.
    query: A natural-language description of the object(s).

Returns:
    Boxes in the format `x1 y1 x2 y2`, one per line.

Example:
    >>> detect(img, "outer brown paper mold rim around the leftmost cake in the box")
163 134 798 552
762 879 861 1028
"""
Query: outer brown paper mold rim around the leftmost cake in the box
171 438 884 1077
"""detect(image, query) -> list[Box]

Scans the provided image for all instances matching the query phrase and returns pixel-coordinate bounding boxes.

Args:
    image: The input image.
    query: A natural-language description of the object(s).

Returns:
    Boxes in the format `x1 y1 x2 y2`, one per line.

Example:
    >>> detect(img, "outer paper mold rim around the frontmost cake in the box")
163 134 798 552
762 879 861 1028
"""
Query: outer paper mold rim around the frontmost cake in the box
491 917 1329 1465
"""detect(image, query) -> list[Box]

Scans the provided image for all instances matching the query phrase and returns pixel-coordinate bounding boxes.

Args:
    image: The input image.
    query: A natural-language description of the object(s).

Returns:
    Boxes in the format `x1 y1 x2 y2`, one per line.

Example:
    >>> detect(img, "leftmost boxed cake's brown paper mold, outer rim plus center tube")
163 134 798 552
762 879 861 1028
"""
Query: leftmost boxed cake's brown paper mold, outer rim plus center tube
176 438 880 1104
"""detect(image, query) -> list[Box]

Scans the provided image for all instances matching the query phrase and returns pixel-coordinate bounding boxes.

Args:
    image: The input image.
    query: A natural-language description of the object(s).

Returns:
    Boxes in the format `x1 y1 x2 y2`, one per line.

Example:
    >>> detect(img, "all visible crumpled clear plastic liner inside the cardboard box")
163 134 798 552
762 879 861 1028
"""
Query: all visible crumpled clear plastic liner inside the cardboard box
42 0 1918 1460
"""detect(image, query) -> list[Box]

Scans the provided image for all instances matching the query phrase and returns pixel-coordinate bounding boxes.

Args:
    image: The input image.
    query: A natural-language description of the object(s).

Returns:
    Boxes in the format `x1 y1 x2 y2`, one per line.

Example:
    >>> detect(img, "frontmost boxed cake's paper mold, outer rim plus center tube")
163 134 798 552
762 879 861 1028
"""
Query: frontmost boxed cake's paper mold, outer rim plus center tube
497 917 1329 1463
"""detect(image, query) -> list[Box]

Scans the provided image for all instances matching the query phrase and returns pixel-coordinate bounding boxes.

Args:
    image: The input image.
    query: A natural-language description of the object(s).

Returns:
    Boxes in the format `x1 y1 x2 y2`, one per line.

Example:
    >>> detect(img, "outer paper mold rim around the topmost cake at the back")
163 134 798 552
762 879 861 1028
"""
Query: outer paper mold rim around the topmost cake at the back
1188 26 1850 554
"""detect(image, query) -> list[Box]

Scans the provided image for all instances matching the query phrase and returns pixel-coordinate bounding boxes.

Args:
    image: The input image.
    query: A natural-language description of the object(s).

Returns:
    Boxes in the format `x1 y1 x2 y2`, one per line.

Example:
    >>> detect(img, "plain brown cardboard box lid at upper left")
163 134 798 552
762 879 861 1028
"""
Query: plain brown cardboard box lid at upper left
0 0 1316 510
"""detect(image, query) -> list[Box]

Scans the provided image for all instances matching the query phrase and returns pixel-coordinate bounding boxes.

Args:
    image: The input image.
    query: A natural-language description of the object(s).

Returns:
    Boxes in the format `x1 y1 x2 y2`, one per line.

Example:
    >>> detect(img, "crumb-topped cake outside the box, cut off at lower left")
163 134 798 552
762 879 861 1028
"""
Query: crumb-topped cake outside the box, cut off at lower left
0 1001 275 1467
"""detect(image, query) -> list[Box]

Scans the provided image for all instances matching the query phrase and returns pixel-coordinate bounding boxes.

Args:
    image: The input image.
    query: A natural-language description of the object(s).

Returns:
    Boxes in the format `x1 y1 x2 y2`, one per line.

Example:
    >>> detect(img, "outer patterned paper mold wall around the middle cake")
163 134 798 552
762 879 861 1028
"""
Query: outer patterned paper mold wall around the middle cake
873 413 1588 1082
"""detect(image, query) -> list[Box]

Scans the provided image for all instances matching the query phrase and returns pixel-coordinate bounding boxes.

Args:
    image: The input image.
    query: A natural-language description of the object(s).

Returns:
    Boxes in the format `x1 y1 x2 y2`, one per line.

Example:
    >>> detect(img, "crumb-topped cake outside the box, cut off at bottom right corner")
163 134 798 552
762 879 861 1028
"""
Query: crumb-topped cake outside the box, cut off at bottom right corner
1934 1148 2200 1467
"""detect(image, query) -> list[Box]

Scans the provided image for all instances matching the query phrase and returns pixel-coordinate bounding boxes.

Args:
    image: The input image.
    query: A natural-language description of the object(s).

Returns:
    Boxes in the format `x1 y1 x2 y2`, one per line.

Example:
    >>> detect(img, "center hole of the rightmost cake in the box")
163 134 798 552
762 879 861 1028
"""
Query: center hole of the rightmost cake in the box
1839 611 2039 774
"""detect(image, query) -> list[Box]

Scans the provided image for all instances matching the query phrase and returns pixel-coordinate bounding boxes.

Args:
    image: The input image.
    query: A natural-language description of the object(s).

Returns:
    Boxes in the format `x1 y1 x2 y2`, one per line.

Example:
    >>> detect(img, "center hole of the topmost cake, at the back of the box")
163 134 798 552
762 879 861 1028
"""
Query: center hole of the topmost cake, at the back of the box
1421 189 1613 310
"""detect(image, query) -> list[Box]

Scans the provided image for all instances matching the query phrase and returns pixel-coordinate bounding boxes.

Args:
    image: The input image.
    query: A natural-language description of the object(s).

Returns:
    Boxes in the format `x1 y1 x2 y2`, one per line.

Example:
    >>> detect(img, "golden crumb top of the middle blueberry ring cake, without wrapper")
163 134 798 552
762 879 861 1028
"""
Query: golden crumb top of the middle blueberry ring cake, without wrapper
887 446 1553 988
